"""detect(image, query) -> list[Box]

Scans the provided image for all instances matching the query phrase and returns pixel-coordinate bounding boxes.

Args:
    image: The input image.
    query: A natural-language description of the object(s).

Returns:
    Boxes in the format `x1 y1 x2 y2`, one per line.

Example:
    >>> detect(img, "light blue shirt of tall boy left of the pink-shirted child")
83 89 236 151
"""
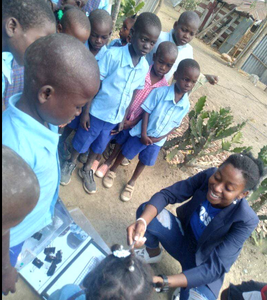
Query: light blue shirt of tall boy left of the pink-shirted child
90 45 149 124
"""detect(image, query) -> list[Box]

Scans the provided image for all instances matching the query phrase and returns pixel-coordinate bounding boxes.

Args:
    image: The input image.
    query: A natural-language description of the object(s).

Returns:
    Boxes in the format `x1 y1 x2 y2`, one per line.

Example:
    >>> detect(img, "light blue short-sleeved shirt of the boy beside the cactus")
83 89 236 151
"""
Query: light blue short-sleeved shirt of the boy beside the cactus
130 84 190 147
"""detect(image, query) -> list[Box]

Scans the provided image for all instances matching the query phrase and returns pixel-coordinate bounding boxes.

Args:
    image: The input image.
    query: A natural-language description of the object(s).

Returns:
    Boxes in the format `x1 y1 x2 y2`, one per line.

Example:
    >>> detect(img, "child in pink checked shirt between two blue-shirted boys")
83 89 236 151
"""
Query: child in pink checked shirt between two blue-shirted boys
96 42 178 178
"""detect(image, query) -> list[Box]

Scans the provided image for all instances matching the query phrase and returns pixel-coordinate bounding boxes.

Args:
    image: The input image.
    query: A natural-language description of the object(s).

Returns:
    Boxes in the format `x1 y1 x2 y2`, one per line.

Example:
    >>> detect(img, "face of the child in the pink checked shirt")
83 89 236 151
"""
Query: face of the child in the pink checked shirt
153 52 176 77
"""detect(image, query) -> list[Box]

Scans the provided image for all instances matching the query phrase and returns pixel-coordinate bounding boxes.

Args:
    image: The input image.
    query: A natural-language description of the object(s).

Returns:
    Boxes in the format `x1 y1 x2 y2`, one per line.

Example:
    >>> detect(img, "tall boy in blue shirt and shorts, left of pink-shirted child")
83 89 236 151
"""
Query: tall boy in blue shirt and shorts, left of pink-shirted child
61 13 161 193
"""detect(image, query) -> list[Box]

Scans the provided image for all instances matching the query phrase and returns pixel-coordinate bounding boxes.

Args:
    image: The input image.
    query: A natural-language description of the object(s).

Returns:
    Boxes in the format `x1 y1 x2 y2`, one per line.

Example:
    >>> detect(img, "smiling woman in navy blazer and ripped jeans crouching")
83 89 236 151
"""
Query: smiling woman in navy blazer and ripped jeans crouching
128 153 266 300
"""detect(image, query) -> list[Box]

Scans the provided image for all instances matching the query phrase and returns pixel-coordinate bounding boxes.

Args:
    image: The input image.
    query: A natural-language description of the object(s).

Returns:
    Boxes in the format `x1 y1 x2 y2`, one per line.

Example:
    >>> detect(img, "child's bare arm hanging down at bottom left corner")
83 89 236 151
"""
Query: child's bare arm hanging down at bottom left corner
2 230 18 295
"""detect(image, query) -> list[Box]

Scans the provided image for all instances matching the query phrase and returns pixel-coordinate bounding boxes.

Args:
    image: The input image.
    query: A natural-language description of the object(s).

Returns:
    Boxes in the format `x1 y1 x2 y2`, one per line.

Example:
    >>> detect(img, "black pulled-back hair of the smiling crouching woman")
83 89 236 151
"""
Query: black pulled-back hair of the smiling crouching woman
220 152 266 191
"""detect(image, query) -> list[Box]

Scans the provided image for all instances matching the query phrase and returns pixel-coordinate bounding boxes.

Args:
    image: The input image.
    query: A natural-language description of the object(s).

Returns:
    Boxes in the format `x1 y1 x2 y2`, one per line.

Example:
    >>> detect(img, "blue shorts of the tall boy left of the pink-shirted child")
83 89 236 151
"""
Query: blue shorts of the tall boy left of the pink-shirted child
72 115 117 154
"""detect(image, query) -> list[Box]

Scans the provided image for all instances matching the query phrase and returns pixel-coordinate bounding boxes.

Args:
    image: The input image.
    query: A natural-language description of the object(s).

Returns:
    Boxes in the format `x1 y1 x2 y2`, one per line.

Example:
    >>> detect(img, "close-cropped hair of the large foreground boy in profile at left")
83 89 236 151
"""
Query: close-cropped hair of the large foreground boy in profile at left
24 33 100 94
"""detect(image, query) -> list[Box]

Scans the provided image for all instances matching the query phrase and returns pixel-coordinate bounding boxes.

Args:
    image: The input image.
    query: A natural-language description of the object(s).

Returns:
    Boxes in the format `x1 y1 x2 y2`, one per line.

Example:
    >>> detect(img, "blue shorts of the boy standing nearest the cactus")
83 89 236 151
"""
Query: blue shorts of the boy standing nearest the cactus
122 136 161 166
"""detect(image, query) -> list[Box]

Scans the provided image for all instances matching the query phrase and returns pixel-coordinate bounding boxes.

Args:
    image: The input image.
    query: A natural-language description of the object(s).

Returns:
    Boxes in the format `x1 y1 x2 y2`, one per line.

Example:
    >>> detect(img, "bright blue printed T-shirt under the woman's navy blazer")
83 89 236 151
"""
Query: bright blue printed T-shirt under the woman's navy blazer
190 200 222 241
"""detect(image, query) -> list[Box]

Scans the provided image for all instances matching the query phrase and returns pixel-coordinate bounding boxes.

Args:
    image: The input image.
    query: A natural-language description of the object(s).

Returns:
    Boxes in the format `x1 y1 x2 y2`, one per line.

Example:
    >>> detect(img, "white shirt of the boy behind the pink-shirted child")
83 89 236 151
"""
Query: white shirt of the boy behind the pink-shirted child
146 29 193 81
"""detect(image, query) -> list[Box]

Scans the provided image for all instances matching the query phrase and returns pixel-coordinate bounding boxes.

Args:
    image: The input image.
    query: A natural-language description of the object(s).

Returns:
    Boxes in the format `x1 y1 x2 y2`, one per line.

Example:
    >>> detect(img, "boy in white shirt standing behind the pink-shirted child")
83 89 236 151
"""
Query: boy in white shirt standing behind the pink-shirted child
146 11 218 84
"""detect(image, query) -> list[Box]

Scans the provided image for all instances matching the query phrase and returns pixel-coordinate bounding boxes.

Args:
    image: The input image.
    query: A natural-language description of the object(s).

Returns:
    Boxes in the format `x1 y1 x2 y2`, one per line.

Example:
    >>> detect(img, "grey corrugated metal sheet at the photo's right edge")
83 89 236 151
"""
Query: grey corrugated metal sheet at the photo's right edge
241 35 267 85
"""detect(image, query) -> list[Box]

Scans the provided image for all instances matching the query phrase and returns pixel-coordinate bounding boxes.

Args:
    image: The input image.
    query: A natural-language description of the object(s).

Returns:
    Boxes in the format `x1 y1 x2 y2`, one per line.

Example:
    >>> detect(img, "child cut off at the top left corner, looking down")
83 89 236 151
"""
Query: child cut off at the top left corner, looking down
2 0 56 106
